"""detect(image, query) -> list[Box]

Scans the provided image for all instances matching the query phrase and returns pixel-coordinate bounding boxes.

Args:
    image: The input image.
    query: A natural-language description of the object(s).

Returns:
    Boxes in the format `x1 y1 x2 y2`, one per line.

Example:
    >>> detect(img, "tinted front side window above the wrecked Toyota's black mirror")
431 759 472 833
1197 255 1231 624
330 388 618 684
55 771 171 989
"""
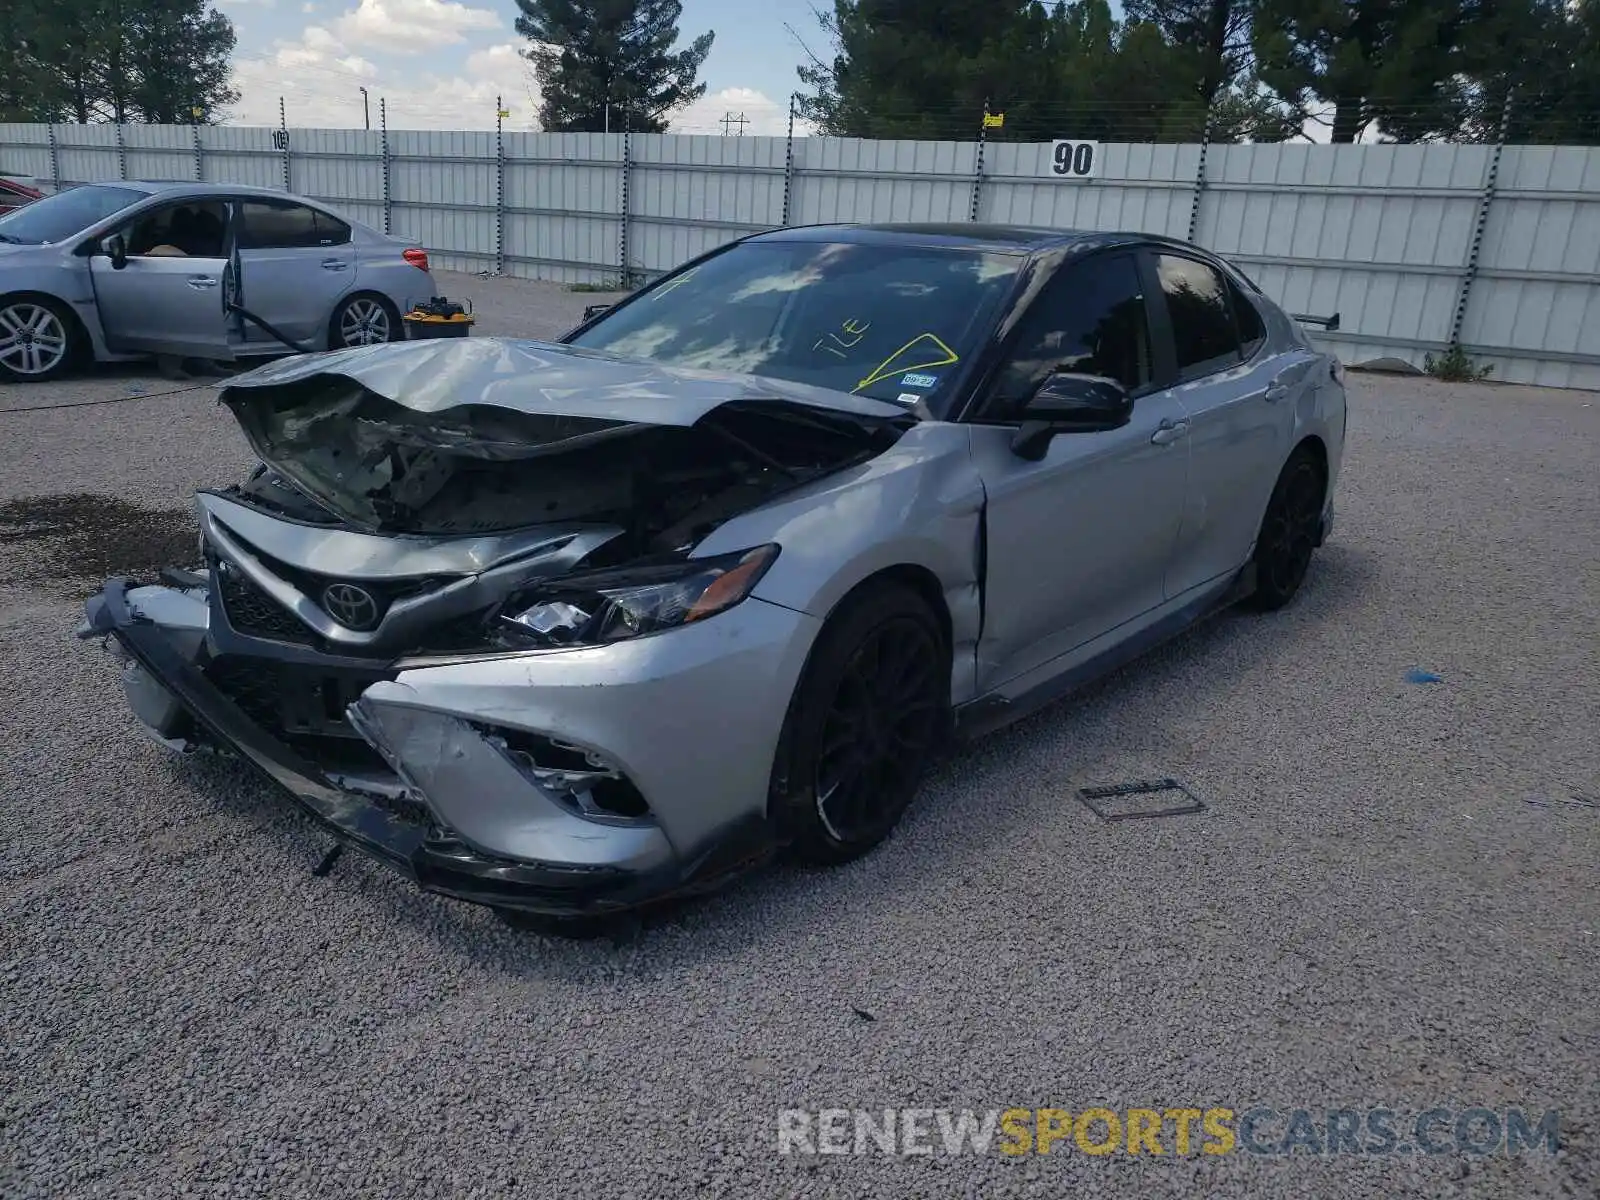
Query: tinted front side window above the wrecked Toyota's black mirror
987 254 1150 419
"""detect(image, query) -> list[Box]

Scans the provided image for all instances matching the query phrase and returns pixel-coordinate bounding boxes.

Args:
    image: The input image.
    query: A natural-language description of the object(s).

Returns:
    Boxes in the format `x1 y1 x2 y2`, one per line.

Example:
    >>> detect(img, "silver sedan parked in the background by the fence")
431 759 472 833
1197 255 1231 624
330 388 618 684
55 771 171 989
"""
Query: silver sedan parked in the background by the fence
0 182 434 381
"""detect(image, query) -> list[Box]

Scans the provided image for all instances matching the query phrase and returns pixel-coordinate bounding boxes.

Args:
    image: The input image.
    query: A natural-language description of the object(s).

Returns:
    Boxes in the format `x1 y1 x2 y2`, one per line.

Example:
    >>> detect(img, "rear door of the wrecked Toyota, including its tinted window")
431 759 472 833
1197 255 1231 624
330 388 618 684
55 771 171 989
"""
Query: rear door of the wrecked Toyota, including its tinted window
1147 246 1298 597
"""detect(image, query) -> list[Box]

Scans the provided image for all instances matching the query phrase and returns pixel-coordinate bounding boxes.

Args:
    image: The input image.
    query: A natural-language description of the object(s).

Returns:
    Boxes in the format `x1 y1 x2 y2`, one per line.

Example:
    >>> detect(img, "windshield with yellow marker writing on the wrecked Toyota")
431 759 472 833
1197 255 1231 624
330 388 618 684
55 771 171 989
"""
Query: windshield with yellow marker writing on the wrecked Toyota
571 242 1024 405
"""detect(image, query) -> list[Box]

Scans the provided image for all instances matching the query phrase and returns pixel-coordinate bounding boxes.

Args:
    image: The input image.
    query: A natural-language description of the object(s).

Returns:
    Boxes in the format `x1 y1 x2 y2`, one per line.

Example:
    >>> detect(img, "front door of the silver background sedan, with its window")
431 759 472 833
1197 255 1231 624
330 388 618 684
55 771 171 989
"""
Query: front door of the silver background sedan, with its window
90 198 234 358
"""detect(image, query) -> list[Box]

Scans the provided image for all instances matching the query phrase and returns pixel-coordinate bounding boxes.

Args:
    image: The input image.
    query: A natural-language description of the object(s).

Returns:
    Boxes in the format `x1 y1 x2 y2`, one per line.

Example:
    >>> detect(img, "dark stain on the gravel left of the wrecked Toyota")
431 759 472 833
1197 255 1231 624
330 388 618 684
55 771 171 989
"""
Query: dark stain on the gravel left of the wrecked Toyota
0 493 198 597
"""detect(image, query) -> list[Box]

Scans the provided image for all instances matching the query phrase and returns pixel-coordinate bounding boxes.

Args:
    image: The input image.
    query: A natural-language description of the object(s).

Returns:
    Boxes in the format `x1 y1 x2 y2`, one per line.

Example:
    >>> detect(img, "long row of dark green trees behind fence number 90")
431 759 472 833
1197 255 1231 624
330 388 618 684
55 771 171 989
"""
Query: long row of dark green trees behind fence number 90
800 0 1600 144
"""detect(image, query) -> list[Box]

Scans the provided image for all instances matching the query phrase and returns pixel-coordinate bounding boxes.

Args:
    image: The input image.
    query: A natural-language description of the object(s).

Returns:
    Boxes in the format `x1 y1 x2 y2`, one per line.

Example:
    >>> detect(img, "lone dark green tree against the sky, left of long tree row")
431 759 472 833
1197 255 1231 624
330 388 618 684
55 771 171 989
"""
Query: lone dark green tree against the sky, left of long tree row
517 0 714 133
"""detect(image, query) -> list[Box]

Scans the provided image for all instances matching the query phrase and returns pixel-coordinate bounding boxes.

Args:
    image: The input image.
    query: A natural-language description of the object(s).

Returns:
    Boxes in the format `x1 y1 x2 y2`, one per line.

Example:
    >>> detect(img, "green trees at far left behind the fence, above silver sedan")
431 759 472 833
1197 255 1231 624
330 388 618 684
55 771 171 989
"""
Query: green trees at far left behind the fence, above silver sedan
0 0 238 123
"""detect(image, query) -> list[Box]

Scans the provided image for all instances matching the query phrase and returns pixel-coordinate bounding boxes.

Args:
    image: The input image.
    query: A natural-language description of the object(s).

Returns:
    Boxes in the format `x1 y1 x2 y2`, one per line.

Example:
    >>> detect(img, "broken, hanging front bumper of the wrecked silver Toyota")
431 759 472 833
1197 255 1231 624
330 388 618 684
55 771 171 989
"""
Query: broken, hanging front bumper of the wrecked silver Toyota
78 573 816 917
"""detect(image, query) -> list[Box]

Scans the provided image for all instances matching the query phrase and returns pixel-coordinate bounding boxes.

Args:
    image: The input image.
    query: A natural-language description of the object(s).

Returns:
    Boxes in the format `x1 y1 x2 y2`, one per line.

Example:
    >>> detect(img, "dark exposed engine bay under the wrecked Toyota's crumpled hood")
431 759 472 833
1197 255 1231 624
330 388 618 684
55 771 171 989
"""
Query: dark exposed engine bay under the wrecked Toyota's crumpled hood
224 376 899 565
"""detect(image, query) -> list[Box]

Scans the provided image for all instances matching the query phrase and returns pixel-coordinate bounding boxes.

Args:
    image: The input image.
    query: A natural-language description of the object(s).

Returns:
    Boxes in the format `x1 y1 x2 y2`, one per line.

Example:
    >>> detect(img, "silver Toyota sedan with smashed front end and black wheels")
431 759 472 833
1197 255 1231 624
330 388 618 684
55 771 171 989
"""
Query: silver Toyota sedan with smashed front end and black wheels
78 226 1346 925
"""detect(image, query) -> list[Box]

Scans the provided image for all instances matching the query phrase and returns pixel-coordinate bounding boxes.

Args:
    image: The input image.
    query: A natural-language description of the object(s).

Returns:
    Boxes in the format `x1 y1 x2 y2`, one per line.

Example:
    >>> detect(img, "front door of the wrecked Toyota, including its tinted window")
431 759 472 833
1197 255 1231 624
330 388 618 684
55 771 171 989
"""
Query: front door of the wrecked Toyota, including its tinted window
971 251 1189 690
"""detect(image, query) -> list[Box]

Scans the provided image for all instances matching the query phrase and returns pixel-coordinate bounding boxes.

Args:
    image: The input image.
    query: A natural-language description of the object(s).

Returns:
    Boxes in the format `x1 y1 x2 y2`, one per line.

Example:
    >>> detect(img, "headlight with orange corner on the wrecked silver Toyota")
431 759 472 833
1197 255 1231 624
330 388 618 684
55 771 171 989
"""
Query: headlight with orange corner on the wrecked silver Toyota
496 546 778 648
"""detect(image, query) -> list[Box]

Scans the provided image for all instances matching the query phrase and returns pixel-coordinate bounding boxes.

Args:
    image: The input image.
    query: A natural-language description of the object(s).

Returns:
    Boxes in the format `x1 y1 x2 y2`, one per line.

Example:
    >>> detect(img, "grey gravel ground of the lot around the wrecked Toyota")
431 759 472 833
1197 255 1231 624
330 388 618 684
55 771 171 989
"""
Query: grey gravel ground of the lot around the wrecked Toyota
0 275 1600 1200
